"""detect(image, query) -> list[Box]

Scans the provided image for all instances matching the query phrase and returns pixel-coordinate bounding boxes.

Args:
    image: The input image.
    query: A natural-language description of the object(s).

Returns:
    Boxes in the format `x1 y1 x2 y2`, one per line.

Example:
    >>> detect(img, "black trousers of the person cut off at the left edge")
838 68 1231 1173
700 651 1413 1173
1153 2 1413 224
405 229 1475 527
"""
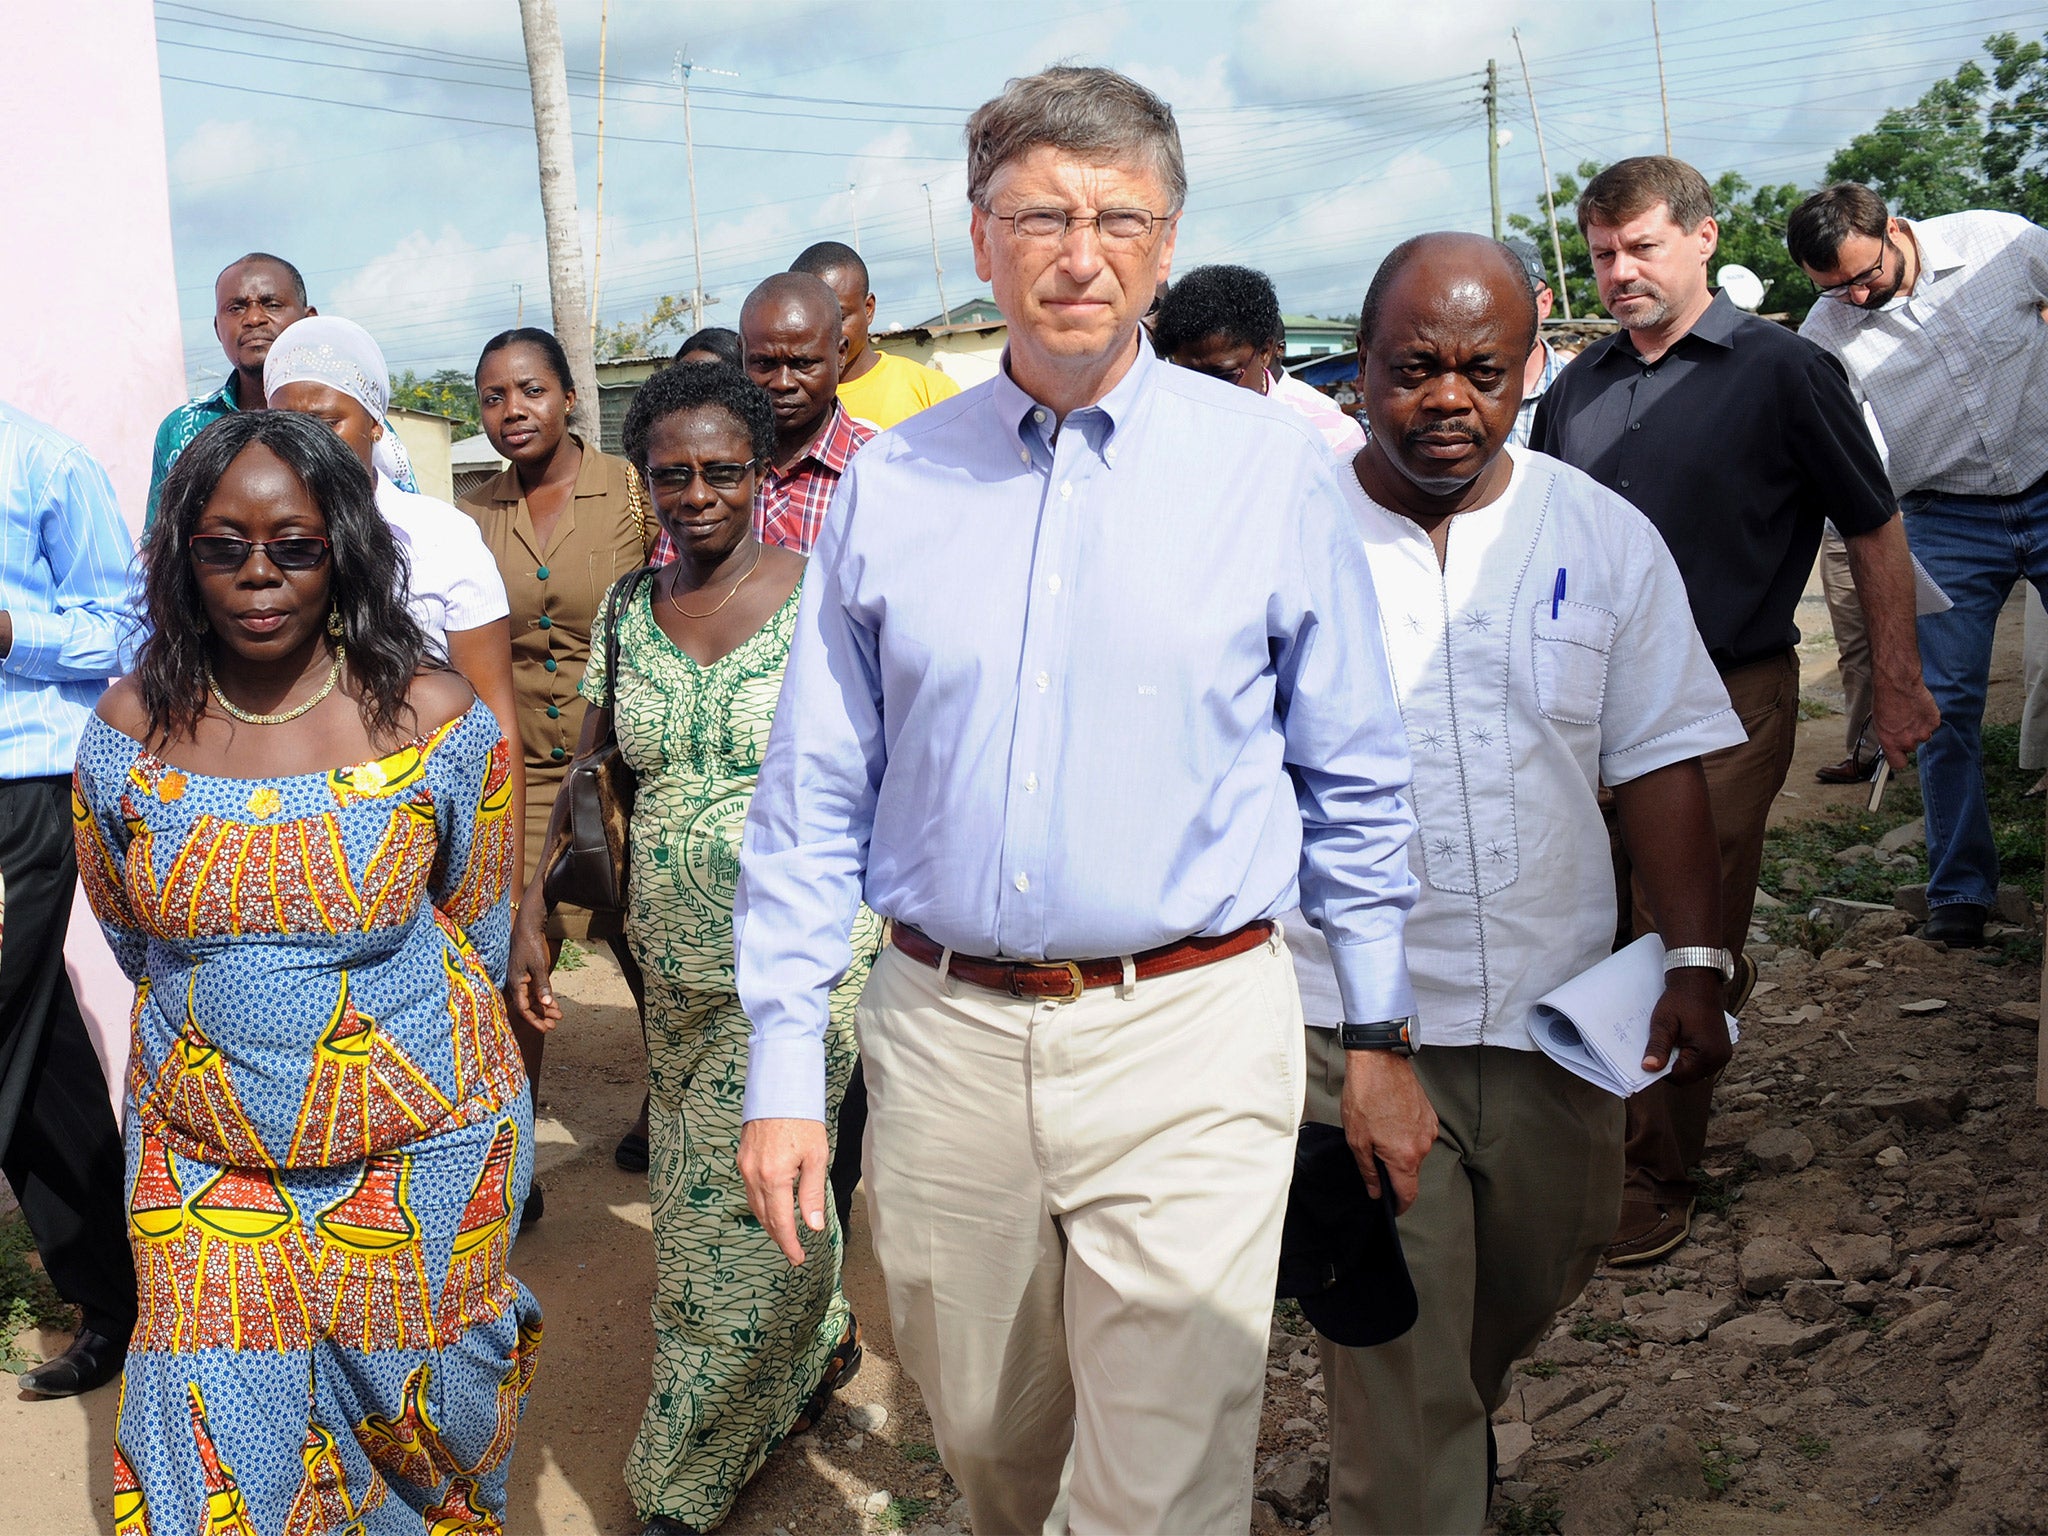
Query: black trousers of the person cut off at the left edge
0 778 135 1339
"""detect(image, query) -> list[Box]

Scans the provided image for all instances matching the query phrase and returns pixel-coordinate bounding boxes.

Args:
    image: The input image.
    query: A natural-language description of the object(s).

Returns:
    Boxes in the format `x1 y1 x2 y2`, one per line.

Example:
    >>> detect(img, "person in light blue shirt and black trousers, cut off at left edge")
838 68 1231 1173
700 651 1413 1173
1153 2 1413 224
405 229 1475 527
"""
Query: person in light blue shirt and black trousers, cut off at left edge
0 403 137 1397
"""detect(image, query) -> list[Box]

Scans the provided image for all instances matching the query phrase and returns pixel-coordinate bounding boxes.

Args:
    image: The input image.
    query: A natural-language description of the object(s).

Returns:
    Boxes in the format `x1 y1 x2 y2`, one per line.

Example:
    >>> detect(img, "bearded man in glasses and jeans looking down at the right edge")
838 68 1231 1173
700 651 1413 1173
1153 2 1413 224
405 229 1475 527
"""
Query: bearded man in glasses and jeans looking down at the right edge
1786 182 2048 946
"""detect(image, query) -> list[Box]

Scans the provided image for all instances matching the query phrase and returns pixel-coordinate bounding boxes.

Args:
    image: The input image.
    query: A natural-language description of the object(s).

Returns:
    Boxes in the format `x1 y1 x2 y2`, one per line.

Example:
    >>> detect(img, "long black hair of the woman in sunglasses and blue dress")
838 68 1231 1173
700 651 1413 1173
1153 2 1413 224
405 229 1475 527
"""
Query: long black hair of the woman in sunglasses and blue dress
135 412 428 739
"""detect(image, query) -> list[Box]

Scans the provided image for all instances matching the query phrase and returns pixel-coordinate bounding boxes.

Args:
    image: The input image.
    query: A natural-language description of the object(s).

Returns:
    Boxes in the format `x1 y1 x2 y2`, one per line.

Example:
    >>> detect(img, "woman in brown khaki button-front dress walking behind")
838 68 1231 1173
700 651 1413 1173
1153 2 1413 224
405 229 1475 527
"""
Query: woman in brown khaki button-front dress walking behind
459 326 657 1225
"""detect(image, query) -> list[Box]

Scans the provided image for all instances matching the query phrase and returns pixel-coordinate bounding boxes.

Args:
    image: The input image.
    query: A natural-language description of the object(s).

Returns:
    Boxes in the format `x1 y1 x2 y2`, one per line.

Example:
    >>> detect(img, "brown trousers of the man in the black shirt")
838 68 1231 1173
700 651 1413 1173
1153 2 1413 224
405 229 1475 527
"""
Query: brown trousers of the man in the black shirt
1608 651 1798 1204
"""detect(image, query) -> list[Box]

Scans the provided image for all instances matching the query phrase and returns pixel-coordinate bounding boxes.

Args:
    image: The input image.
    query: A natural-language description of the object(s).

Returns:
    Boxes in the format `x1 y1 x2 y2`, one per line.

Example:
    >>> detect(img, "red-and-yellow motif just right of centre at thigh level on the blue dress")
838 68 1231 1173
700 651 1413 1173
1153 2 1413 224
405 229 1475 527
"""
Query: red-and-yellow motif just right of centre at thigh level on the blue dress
313 1153 440 1350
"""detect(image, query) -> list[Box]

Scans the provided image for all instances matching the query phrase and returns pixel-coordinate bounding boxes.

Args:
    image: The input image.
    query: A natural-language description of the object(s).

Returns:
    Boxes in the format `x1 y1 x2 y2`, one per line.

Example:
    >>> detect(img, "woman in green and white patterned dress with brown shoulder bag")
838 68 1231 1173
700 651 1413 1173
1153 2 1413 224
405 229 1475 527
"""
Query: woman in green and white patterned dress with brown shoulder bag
510 365 881 1536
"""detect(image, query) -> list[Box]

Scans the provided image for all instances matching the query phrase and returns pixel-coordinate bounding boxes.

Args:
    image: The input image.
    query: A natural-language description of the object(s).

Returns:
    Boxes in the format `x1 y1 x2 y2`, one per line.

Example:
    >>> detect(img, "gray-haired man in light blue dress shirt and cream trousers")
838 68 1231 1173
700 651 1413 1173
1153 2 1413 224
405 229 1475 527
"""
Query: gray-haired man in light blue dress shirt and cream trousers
735 68 1436 1532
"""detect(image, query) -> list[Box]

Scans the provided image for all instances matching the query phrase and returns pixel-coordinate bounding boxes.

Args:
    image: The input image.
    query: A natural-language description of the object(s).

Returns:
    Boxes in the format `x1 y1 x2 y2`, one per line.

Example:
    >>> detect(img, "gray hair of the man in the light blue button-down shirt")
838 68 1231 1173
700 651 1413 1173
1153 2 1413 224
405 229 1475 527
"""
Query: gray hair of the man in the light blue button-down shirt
967 63 1188 213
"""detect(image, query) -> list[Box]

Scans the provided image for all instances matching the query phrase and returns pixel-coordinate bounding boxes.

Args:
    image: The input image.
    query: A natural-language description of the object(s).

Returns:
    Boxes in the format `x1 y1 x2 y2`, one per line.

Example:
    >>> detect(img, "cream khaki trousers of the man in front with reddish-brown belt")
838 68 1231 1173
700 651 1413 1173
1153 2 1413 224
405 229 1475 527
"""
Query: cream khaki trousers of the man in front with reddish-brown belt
856 936 1303 1536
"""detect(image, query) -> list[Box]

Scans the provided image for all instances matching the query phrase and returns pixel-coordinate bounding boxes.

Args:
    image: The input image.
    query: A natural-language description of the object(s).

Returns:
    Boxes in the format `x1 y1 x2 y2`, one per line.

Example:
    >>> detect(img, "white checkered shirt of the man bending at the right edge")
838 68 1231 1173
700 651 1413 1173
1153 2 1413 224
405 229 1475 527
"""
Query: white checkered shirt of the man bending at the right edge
1800 213 2048 496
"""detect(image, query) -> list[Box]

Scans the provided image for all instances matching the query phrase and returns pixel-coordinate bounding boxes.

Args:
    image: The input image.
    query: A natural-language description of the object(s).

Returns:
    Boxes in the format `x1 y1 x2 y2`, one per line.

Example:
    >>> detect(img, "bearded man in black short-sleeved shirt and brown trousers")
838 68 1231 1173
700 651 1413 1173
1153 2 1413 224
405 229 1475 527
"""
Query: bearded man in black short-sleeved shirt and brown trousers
1532 156 1939 1264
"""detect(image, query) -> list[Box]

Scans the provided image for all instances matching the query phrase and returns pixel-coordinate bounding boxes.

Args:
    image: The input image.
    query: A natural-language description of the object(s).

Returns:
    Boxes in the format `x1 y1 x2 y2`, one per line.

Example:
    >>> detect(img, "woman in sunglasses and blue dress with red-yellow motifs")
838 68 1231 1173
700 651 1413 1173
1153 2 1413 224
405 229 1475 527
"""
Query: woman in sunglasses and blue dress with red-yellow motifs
74 412 541 1536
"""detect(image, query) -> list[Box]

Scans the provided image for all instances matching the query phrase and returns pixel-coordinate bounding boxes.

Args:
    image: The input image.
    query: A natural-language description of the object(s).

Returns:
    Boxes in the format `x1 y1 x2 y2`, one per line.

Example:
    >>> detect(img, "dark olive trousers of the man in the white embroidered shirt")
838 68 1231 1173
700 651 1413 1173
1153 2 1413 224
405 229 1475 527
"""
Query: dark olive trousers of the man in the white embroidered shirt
1309 1030 1622 1536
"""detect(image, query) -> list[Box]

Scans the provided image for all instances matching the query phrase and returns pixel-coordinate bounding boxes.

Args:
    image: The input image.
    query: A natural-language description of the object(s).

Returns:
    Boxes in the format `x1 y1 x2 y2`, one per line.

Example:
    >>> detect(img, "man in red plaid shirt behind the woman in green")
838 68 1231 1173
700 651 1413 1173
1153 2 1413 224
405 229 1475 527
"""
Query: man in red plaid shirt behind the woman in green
653 272 874 565
